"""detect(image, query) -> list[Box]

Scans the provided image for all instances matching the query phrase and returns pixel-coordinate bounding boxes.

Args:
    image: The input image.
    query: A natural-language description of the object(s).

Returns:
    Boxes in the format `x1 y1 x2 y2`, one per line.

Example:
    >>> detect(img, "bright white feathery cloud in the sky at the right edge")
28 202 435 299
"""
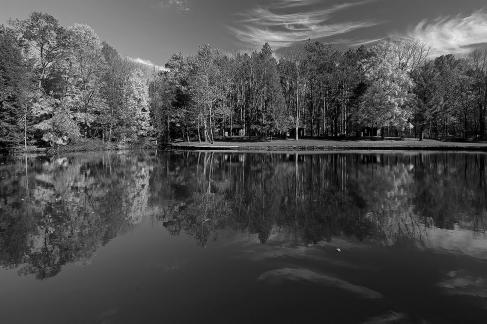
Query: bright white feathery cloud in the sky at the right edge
408 10 487 55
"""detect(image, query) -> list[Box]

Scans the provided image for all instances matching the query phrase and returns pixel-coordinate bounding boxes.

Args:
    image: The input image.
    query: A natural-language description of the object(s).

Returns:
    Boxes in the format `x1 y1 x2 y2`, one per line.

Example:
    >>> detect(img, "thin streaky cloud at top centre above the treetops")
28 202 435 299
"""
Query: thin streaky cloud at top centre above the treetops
229 0 378 48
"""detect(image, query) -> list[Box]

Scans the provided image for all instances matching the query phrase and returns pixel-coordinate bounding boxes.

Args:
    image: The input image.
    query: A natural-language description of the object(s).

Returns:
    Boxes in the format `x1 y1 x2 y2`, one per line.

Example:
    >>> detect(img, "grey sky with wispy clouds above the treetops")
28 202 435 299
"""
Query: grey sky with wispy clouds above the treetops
0 0 487 65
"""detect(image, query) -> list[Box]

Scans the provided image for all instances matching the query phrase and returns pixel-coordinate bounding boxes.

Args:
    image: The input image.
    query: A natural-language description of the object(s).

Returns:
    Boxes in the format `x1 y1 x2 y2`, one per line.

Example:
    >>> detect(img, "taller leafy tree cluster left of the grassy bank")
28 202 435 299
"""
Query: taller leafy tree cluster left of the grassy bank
0 12 152 147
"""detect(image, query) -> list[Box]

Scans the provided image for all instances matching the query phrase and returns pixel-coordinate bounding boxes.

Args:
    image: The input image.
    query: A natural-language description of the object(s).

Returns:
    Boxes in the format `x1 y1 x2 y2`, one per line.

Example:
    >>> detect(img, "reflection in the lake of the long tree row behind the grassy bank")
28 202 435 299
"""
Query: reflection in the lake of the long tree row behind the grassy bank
151 152 487 245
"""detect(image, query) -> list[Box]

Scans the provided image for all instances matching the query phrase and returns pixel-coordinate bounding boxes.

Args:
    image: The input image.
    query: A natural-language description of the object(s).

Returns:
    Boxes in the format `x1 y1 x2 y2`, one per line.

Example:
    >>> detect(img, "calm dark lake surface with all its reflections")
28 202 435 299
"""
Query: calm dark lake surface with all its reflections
0 152 487 324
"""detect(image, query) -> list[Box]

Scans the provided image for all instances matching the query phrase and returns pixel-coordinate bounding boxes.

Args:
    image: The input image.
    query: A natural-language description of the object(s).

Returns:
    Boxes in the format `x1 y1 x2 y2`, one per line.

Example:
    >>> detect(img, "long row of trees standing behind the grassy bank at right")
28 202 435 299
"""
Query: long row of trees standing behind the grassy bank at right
151 39 487 141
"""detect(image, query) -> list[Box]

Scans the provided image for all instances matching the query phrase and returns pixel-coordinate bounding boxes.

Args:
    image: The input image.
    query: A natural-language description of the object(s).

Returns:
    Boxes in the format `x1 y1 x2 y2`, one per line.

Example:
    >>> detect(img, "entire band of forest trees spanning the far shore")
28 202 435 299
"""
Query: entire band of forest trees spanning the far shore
0 12 487 147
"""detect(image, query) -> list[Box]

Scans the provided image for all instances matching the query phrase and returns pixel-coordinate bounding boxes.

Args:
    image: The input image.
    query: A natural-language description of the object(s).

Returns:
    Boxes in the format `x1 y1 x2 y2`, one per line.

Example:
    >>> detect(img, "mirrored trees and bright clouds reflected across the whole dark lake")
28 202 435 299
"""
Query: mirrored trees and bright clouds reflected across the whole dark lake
0 152 487 280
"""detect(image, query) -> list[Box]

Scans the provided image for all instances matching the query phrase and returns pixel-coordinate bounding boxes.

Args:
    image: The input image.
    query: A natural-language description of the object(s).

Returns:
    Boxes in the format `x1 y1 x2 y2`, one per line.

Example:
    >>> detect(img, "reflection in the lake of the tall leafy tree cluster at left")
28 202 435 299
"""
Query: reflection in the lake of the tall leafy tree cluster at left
0 155 153 279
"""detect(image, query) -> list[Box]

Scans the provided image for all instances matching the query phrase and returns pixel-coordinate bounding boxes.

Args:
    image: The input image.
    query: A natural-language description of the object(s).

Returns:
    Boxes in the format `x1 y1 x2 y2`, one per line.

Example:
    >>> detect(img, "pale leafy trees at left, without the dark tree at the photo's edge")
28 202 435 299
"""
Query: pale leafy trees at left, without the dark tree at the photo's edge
3 12 152 145
